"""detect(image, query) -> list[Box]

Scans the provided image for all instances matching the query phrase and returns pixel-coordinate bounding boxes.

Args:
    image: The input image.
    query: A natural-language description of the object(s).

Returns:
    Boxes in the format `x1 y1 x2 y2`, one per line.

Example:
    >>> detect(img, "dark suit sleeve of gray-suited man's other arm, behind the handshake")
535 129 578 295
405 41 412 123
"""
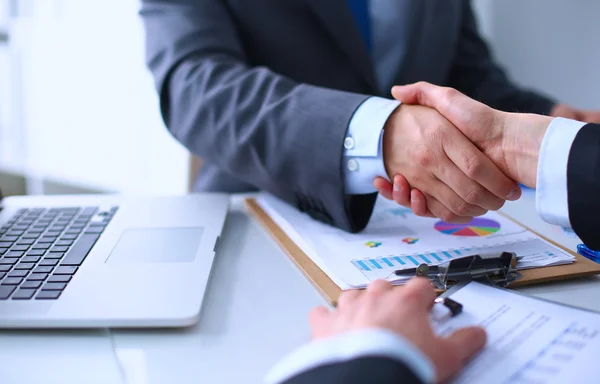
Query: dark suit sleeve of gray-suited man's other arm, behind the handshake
449 0 555 115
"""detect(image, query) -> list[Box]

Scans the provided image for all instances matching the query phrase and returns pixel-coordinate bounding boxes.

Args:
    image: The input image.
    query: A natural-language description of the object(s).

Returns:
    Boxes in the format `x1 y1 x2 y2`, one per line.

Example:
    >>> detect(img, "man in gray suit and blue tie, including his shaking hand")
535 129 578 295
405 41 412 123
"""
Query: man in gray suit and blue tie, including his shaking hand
141 0 585 231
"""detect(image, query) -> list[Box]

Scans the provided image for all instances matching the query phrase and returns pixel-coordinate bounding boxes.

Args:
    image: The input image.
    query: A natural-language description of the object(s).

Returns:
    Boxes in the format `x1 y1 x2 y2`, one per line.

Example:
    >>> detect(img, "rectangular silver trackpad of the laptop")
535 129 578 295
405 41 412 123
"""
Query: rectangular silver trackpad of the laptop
105 227 204 263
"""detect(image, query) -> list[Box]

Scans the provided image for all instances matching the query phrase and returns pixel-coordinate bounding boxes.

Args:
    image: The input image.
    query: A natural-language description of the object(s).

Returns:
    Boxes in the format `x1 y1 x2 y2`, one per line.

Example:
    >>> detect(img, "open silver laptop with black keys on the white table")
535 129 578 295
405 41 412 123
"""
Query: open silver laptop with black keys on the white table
0 189 229 328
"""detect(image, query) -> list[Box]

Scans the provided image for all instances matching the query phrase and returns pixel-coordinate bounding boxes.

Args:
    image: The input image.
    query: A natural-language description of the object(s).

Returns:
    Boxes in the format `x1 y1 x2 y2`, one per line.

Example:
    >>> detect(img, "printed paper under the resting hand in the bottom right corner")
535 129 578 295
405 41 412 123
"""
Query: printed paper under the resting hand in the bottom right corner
432 282 600 384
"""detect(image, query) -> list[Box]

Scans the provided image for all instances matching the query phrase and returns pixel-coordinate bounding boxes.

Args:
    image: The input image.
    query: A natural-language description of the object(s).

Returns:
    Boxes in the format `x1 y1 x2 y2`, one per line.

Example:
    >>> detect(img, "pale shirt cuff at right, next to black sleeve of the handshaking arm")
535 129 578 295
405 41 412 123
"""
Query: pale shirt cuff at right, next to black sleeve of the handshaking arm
535 117 586 227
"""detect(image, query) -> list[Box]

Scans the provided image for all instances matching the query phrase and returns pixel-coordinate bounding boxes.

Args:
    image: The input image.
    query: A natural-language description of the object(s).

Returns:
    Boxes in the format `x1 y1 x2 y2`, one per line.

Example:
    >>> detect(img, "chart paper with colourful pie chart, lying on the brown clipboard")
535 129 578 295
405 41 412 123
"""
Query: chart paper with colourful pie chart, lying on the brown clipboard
257 195 575 289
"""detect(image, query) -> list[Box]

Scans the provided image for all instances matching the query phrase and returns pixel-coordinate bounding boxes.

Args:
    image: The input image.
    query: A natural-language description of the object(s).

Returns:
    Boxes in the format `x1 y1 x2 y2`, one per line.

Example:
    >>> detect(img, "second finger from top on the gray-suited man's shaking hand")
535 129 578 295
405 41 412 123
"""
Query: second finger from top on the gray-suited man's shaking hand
435 154 506 212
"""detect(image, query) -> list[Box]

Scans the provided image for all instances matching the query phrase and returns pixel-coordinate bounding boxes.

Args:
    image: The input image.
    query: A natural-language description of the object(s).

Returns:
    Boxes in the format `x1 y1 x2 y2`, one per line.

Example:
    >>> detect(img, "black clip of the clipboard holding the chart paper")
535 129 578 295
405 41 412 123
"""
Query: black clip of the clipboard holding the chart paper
394 252 522 289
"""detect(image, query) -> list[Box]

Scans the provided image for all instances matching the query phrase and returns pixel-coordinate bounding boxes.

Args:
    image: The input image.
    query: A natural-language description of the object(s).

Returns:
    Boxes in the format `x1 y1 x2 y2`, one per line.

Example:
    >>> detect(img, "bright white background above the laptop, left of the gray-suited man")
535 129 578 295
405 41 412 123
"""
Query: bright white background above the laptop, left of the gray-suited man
0 0 189 194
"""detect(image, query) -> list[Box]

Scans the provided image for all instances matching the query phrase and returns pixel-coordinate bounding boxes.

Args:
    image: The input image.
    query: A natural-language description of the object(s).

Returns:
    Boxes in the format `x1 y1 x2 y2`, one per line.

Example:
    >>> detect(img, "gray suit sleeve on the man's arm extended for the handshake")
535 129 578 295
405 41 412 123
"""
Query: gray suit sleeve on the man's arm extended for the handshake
140 0 374 231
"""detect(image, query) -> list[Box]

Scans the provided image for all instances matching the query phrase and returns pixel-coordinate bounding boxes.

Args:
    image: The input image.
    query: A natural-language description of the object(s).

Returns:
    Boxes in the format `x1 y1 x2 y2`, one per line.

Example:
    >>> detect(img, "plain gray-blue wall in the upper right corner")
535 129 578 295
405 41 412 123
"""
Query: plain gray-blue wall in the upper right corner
474 0 600 109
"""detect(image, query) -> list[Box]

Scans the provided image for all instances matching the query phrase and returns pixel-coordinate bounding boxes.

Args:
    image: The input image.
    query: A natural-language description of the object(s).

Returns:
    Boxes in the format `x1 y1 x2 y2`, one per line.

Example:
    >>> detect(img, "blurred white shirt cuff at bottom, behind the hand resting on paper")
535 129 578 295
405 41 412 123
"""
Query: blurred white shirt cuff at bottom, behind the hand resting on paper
266 329 435 384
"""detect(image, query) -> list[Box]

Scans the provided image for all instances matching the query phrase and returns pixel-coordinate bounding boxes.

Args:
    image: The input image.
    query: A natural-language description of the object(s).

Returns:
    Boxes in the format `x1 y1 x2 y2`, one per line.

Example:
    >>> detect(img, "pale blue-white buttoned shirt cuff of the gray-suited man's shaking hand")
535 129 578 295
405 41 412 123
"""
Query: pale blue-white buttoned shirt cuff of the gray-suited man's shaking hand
343 97 400 195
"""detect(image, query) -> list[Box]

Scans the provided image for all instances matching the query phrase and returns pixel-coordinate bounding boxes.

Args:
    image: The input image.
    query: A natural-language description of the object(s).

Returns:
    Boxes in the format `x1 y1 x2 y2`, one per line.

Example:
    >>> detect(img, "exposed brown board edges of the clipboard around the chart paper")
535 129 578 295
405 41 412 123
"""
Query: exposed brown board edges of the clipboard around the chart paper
244 198 600 305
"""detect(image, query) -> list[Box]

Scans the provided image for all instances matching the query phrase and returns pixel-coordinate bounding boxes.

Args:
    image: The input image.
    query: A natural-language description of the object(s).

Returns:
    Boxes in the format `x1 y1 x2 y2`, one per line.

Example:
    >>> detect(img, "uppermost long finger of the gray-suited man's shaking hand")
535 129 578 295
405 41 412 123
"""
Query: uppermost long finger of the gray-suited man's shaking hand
438 131 521 202
